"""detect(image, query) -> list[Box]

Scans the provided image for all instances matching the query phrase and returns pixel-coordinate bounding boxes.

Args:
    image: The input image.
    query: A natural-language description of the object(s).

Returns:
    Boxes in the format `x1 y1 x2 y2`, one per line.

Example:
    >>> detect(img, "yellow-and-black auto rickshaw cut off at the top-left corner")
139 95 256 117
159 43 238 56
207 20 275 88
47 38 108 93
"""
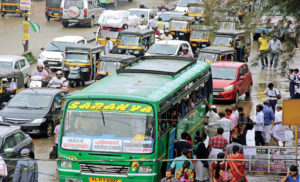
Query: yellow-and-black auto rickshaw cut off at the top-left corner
0 0 24 17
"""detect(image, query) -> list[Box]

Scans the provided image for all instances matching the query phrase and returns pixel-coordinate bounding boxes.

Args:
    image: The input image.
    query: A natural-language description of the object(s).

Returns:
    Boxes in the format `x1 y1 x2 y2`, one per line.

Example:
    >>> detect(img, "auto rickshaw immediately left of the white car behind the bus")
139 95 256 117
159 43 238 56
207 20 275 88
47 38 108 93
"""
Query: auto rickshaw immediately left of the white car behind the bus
112 29 155 57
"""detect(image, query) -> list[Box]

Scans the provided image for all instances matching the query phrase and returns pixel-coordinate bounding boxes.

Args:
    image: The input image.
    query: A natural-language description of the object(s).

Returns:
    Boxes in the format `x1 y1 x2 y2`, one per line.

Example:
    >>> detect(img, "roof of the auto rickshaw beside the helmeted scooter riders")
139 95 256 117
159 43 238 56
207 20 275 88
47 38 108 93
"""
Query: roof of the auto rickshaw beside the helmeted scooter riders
65 44 105 53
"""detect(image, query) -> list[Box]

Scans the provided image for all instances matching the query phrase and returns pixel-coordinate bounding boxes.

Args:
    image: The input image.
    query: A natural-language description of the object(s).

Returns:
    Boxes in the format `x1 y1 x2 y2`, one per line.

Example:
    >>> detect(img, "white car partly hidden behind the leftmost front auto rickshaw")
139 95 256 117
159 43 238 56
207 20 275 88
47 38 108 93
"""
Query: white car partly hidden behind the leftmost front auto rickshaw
38 36 87 69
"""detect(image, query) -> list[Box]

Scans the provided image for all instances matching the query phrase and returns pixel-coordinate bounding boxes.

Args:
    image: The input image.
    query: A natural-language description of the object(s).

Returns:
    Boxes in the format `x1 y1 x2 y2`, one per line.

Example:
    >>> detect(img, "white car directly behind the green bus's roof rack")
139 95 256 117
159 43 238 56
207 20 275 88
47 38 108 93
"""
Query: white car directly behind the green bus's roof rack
145 40 193 56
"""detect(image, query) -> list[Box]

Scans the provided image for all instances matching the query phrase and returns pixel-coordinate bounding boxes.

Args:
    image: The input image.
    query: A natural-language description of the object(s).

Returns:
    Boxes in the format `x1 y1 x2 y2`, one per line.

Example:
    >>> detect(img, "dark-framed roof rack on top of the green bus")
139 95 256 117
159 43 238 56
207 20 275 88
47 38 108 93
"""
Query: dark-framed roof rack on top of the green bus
117 56 197 77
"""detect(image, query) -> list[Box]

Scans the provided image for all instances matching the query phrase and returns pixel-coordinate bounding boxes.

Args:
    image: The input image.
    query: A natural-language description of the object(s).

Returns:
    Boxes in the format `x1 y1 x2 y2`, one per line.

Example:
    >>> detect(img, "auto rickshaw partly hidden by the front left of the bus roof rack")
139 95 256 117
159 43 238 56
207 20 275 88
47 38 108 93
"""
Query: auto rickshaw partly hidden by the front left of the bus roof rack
96 54 137 80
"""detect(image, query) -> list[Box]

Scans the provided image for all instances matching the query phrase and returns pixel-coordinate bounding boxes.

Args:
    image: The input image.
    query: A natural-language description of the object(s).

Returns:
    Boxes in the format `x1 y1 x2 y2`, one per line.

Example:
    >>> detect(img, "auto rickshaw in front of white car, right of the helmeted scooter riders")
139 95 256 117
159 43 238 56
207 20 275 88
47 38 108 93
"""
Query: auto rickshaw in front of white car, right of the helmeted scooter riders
63 44 104 87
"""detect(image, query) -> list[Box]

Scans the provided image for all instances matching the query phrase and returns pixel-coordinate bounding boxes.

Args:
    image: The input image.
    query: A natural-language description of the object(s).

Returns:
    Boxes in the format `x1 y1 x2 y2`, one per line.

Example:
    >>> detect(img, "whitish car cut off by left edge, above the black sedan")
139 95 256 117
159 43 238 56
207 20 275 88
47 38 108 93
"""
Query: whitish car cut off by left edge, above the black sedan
0 55 31 84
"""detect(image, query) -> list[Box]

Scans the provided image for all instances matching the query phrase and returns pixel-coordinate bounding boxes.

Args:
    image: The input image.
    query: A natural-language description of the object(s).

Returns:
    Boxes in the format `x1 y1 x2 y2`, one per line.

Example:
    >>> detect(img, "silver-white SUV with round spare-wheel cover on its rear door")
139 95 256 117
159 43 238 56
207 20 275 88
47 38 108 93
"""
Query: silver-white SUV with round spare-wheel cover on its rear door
60 0 103 27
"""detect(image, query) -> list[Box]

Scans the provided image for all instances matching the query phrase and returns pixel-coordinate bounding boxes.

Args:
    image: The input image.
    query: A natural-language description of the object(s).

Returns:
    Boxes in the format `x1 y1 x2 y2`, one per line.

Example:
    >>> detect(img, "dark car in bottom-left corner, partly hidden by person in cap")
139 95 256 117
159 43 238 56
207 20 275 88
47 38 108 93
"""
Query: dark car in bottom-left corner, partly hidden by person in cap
0 124 34 180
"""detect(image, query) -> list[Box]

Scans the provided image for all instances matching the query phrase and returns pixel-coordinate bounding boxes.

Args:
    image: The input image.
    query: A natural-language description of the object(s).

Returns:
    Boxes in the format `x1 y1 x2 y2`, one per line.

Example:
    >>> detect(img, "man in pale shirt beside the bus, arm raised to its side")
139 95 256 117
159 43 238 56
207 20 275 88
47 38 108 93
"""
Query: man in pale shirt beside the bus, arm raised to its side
204 99 220 138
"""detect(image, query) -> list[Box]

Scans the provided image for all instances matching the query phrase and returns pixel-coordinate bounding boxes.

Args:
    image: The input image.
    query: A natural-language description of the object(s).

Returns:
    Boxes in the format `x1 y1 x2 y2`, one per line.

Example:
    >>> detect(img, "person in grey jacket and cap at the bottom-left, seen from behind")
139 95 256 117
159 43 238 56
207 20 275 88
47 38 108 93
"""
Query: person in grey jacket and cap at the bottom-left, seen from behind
13 148 39 182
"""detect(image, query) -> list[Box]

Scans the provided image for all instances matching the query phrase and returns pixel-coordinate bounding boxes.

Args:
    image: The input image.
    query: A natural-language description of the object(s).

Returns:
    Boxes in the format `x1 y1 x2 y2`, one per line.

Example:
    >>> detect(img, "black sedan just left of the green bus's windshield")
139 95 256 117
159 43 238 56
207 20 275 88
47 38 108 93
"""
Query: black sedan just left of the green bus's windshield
0 88 67 137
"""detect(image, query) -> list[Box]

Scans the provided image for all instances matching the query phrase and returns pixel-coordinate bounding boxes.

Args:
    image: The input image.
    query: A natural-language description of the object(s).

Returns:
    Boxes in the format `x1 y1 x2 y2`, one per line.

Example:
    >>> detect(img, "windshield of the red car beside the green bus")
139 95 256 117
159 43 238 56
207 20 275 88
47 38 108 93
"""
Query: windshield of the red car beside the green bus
211 66 237 80
